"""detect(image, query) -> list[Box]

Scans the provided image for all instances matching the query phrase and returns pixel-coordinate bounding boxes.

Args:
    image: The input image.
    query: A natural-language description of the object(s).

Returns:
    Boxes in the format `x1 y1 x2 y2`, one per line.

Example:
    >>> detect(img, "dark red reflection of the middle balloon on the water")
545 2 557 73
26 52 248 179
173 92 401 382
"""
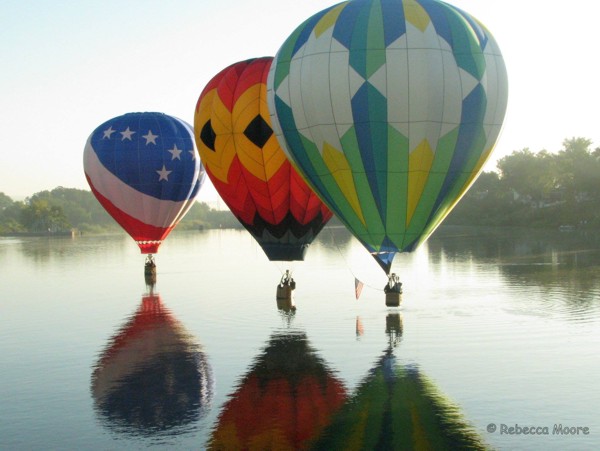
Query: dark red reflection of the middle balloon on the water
209 330 346 450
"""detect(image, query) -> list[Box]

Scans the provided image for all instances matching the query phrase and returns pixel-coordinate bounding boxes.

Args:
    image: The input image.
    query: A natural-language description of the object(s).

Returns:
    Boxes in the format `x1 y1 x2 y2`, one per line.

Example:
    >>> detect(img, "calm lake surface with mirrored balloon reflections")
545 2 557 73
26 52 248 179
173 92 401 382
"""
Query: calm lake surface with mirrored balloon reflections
0 227 600 450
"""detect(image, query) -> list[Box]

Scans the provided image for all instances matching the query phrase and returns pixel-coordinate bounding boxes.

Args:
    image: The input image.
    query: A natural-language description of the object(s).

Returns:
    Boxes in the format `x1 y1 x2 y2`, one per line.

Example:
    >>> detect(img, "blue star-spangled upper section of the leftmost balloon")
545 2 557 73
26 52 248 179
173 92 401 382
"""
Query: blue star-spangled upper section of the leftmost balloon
91 113 200 201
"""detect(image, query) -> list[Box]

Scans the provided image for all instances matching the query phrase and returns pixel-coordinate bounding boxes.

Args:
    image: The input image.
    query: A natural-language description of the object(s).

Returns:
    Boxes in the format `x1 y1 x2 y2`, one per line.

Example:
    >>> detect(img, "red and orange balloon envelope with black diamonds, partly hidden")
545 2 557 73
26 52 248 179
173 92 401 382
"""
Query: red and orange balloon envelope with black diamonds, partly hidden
194 57 332 296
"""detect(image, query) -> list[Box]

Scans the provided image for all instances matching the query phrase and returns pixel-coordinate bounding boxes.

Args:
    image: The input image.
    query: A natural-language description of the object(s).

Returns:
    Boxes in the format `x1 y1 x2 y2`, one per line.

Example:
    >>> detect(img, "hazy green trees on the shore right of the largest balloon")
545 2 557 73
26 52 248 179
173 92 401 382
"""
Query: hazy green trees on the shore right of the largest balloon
445 138 600 228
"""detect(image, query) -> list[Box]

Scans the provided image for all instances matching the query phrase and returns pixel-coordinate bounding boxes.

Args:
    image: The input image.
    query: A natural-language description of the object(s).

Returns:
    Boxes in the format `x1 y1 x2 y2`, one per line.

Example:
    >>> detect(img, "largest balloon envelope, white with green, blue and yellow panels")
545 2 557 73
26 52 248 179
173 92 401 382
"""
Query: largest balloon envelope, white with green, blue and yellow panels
267 0 508 290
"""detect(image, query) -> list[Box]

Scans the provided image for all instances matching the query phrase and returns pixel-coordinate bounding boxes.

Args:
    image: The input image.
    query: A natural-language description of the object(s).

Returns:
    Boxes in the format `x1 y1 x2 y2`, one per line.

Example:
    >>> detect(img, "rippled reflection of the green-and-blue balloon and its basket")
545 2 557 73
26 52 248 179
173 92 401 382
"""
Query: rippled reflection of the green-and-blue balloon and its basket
312 314 486 450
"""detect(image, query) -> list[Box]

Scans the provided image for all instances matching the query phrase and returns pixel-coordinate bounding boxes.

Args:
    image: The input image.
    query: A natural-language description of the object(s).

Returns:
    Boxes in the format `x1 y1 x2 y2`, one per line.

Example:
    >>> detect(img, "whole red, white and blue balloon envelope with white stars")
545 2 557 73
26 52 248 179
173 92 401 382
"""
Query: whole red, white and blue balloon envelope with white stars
83 113 204 254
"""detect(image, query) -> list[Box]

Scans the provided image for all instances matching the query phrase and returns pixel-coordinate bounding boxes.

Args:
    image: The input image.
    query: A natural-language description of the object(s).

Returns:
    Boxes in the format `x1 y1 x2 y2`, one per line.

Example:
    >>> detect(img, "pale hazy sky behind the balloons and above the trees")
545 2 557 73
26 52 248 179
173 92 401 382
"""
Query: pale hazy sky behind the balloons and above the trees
0 0 600 202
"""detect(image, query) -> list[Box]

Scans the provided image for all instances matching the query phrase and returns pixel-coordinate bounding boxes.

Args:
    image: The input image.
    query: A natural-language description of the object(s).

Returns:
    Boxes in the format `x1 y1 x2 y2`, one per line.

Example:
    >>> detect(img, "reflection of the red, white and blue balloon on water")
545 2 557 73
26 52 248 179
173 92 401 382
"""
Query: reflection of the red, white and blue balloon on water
92 291 214 436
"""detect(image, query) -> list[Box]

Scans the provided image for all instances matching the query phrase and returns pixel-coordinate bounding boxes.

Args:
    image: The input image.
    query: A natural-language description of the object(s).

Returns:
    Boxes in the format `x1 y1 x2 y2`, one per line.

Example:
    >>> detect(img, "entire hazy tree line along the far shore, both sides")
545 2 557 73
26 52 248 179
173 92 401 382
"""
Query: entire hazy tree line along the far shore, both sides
0 138 600 234
